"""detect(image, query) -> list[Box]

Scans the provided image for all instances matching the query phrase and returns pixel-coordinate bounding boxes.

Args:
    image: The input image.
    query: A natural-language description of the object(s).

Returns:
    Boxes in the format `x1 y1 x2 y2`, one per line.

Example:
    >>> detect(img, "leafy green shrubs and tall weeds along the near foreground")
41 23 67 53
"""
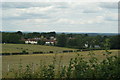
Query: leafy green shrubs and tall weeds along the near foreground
3 50 120 80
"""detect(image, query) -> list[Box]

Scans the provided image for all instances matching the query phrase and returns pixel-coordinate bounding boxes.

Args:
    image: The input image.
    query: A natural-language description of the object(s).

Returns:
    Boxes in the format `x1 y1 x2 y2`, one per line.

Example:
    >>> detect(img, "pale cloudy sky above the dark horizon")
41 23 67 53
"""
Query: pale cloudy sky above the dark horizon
0 2 118 33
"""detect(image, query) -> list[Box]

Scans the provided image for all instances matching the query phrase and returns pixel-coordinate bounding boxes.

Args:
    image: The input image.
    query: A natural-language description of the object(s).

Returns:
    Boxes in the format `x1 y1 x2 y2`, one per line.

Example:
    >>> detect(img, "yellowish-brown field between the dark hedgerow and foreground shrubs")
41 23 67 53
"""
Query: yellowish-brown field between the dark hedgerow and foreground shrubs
2 50 120 76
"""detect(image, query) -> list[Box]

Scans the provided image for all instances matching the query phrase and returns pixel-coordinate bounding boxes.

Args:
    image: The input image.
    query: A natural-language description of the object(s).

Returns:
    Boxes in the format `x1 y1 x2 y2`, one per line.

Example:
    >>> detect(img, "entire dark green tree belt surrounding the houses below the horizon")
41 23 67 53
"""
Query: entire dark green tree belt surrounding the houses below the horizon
0 31 120 49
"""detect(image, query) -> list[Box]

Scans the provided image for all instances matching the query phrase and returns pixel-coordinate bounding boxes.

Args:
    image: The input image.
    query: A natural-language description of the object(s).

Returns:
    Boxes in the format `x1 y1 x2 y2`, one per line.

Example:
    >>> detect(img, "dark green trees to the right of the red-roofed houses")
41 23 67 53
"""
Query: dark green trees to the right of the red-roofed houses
57 34 120 49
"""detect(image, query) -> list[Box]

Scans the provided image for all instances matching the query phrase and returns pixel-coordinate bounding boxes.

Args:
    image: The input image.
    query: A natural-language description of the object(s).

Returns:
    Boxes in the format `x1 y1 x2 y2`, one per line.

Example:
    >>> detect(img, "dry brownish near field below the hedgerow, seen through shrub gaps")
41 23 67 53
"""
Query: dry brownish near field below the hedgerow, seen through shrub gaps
2 50 120 78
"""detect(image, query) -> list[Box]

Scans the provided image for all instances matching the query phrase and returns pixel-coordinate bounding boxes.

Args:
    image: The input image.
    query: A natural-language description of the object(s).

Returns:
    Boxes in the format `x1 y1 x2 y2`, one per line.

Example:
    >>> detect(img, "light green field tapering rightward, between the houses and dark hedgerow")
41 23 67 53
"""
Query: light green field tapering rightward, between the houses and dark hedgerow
2 44 75 53
